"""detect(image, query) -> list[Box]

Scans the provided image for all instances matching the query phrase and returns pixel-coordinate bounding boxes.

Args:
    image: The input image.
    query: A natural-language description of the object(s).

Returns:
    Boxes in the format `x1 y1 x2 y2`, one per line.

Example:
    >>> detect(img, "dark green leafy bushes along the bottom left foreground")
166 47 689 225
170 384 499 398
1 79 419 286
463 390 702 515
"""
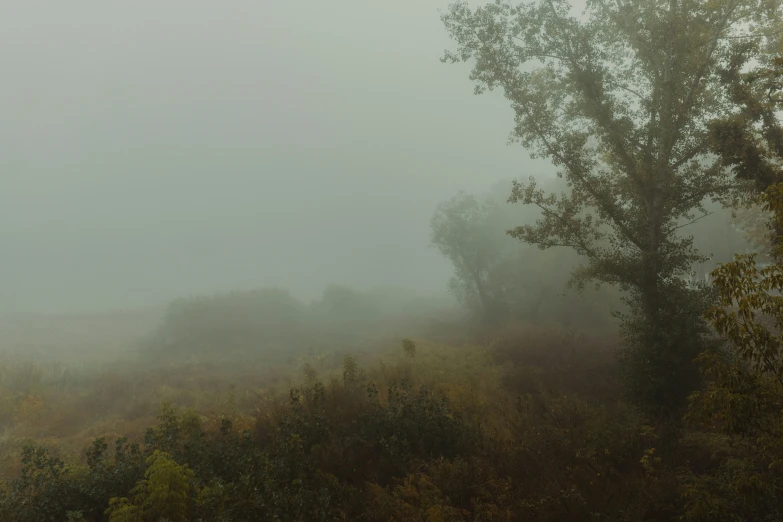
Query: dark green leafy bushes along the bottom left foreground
0 350 484 521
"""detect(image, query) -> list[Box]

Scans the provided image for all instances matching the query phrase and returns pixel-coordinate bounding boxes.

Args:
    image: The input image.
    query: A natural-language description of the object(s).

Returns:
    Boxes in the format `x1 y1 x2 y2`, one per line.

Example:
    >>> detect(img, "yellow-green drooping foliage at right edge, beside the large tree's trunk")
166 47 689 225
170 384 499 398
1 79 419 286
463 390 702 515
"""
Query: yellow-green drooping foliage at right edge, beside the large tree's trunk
683 180 783 521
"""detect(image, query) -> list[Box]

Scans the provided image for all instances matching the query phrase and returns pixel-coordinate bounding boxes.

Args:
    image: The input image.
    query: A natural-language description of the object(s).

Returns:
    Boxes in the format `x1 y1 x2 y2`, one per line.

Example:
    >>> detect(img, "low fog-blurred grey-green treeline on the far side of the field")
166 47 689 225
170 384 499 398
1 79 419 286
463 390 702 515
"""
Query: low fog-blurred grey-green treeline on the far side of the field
141 285 459 361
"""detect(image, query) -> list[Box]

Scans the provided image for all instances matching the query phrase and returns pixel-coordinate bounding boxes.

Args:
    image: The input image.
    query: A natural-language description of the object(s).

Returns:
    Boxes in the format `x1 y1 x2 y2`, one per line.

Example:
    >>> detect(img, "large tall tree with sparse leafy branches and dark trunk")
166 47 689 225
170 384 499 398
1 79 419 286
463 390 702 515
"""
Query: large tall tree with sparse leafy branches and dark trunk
442 0 781 409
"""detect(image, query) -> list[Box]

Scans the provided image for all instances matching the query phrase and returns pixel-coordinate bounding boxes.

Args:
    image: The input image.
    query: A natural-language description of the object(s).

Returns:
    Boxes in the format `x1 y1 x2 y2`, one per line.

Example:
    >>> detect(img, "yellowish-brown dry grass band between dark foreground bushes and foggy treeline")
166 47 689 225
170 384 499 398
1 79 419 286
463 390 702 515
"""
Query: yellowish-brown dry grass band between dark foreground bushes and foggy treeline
0 312 615 478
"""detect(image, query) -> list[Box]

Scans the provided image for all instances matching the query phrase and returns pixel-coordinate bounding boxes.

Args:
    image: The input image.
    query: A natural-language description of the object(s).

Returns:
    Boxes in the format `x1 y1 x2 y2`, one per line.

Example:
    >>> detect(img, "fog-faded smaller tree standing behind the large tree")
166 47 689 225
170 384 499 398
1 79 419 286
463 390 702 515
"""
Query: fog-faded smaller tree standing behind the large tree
431 186 623 329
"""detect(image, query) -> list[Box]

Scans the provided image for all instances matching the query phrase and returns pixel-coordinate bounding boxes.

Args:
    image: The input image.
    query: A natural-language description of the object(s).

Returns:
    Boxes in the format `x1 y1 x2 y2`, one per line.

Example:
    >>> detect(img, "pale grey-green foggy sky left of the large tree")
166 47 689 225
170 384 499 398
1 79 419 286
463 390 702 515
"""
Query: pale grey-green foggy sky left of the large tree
0 0 548 311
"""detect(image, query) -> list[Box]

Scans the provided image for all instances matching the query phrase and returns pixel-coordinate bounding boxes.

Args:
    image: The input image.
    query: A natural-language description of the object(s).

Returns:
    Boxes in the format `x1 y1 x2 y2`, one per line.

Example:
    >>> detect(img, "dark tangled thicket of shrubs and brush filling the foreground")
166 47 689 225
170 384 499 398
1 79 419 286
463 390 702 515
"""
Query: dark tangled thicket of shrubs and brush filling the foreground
0 331 676 521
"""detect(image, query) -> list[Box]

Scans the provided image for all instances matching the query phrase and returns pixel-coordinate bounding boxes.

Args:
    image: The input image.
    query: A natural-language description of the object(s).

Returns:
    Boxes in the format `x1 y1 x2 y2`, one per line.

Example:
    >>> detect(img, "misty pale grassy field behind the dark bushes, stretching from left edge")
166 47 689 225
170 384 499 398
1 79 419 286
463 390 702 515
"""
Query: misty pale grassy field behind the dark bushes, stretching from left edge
0 300 472 479
